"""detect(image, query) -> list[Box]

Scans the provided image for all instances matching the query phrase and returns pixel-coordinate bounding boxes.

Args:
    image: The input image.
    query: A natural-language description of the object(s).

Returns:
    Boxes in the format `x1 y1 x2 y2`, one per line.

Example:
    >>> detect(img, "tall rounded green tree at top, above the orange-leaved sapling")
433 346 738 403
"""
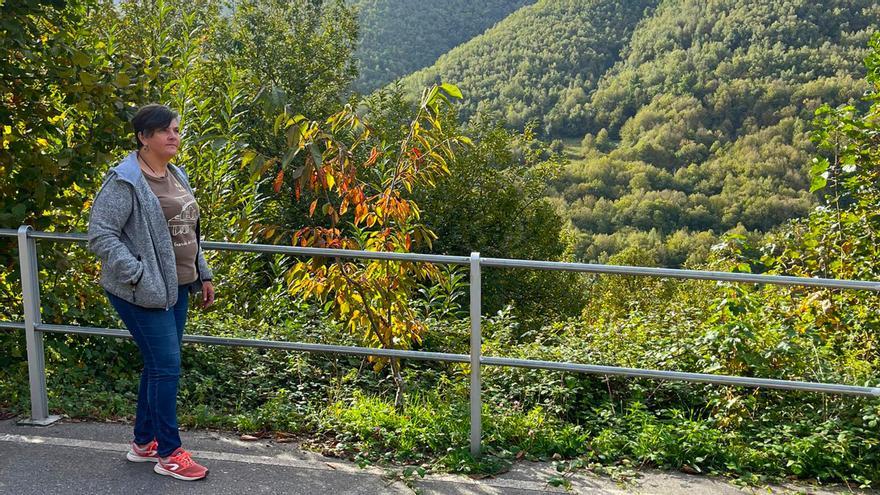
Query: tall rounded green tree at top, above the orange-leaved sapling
225 0 358 156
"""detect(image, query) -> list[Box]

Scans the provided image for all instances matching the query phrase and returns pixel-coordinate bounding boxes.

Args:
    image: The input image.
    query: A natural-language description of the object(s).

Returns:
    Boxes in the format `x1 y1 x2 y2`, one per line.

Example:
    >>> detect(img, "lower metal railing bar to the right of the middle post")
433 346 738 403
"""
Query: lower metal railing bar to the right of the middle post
481 356 880 397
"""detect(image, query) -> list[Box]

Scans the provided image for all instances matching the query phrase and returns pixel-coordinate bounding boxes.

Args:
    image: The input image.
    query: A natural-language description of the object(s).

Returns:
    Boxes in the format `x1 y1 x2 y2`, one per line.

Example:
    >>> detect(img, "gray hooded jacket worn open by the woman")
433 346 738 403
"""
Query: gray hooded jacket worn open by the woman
89 152 213 309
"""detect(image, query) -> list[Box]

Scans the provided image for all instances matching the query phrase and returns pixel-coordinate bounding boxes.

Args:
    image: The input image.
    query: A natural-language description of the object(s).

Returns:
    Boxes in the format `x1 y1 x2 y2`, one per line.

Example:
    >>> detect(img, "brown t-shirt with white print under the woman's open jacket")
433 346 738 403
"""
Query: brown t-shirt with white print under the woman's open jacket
144 170 199 285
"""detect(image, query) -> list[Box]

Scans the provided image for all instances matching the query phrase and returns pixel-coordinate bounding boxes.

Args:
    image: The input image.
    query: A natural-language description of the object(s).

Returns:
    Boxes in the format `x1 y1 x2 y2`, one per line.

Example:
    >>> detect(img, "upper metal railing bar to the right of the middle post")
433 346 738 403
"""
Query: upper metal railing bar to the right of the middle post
481 258 880 291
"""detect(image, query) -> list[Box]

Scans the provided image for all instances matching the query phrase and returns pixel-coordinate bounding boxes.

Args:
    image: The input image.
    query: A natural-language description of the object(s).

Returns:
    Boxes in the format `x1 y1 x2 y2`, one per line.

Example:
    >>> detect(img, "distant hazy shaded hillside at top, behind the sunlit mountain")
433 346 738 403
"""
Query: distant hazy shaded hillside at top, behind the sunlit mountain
351 0 534 92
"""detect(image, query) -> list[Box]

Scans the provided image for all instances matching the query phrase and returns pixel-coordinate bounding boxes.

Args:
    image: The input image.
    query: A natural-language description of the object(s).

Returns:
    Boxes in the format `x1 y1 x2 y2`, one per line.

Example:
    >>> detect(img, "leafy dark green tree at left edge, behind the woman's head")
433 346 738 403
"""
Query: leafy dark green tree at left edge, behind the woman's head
0 0 149 232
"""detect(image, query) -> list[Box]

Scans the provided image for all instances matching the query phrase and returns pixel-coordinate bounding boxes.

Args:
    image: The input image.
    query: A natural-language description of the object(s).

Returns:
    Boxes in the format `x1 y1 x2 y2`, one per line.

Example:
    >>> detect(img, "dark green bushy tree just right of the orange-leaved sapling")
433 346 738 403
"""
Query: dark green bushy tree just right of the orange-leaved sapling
418 118 582 325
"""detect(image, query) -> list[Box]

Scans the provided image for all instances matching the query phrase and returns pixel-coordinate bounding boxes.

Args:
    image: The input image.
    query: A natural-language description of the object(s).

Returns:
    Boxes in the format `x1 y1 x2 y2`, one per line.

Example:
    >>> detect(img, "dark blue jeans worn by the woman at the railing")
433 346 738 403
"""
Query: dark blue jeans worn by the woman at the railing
107 286 189 457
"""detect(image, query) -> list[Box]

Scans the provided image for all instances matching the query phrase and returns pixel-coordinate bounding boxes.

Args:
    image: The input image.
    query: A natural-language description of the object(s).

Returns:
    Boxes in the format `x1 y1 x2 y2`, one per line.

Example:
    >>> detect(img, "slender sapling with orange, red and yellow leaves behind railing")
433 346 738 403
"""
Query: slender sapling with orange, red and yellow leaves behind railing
274 84 469 406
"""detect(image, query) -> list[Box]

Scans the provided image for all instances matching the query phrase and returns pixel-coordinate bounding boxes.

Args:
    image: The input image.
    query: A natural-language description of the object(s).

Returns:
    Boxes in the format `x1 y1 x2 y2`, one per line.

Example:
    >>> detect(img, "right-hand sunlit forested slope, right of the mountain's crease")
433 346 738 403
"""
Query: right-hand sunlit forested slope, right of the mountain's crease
554 0 880 264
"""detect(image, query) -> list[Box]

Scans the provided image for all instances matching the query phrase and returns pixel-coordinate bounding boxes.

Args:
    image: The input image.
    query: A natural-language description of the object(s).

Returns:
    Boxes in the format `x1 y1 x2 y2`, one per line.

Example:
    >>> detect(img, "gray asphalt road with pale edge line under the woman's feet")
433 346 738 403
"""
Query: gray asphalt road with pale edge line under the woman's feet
0 420 868 495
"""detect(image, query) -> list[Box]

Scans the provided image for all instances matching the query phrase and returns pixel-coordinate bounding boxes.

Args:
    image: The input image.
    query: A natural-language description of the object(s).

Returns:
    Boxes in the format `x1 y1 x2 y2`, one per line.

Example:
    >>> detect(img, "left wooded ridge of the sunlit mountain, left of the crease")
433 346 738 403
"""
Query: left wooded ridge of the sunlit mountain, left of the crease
404 0 656 135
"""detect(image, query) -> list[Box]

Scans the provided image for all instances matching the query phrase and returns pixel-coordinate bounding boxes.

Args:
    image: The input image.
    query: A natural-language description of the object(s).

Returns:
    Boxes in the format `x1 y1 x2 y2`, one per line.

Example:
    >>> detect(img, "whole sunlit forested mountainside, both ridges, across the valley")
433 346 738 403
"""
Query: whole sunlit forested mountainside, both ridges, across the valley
405 0 880 265
